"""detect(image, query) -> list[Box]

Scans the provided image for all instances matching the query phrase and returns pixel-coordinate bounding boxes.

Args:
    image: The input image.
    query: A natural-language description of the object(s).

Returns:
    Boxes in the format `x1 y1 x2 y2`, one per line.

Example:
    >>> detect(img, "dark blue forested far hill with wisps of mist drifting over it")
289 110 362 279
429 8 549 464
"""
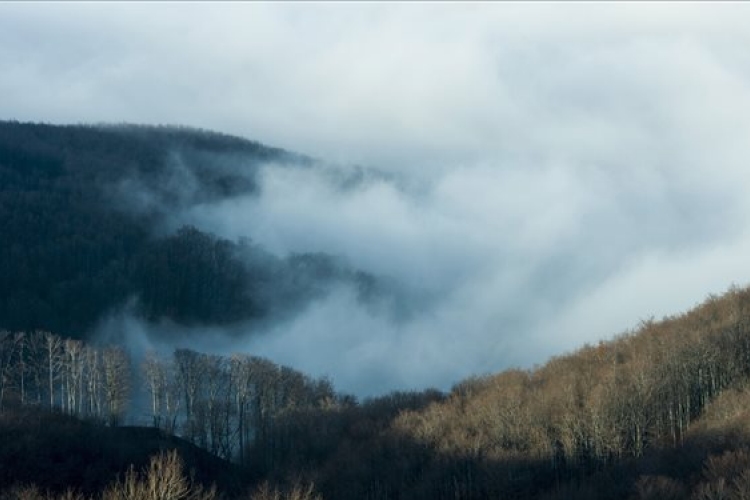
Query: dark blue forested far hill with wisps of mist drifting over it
0 122 372 338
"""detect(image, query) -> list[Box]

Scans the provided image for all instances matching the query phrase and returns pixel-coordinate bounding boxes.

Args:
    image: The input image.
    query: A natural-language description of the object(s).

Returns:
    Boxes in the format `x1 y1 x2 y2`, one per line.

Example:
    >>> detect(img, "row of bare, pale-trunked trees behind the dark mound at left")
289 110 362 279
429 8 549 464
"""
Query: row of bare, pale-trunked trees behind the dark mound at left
0 331 344 463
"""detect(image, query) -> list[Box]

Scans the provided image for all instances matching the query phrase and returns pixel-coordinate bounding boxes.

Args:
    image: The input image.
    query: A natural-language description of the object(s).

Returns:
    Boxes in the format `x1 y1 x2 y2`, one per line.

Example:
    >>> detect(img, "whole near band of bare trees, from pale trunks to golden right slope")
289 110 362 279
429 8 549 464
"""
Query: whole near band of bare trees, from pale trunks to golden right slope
0 288 750 500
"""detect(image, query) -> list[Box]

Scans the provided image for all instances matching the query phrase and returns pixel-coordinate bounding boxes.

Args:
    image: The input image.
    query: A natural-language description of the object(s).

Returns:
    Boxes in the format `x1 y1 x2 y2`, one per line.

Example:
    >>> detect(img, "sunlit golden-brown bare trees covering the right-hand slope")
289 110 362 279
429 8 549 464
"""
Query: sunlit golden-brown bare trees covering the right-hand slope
382 287 750 498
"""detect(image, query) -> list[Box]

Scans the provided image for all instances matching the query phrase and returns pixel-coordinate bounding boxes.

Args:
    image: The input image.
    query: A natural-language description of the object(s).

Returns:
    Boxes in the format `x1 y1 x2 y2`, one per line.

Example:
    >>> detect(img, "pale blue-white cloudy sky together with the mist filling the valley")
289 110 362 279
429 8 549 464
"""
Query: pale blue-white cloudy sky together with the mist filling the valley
0 2 750 394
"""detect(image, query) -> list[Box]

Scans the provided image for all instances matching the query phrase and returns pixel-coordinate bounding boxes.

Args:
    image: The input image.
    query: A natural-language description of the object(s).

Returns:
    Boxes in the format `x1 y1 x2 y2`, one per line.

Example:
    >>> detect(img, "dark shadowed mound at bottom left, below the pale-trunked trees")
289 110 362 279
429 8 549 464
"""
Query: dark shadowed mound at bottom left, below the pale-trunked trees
0 407 244 496
